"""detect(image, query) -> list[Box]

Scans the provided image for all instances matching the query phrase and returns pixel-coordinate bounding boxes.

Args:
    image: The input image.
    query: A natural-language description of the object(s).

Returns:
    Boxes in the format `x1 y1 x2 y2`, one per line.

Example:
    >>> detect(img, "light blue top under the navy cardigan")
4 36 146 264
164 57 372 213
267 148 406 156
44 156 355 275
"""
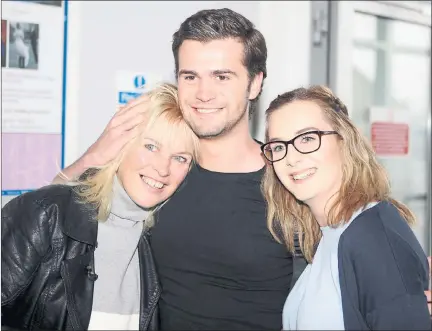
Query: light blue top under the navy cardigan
282 203 377 330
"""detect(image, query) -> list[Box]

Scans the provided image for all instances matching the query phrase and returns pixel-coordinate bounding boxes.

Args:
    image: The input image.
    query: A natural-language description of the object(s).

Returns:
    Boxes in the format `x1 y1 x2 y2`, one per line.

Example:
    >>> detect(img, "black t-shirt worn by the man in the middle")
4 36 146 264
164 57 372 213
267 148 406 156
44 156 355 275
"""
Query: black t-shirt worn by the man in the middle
151 166 293 330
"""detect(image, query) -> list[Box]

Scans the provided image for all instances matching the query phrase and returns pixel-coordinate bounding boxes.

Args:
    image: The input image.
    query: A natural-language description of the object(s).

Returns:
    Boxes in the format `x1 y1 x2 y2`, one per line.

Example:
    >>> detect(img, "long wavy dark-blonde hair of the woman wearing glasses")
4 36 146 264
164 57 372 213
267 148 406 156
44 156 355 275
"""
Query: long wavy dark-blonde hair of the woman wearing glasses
261 86 415 262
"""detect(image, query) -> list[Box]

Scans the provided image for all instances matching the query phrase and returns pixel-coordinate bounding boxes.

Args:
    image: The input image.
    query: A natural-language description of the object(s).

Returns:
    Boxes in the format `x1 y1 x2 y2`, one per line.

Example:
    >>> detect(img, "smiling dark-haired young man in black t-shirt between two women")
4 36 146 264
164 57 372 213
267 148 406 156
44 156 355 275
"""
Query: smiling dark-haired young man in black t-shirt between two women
56 9 293 330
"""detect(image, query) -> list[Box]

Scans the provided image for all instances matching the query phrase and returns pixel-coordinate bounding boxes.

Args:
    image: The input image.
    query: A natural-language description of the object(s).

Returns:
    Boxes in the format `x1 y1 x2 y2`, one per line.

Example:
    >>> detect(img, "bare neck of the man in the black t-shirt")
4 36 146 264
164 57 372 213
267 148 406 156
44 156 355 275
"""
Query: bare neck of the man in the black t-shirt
199 123 265 173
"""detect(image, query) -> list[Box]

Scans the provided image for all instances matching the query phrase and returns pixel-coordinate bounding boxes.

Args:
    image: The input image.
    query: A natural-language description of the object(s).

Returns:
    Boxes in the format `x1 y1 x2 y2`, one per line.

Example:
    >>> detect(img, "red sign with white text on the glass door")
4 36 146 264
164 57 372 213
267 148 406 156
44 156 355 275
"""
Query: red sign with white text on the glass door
371 122 409 156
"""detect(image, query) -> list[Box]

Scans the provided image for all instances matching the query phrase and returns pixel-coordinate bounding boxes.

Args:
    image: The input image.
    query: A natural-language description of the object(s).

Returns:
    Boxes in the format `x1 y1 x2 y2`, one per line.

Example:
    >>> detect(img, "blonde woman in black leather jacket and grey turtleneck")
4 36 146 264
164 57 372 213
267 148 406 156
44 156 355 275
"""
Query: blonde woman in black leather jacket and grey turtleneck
1 84 198 330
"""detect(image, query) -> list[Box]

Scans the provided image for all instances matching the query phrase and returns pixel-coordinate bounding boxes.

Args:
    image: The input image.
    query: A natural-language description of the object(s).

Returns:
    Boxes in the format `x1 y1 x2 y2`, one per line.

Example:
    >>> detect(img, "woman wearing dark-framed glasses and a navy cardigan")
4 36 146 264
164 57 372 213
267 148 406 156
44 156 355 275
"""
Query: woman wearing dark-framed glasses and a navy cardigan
262 86 431 330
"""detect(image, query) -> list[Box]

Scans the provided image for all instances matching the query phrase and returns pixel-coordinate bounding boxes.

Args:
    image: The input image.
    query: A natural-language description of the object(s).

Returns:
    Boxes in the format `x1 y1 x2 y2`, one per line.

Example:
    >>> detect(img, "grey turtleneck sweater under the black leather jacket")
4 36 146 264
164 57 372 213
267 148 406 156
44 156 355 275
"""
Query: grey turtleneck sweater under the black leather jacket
88 177 148 330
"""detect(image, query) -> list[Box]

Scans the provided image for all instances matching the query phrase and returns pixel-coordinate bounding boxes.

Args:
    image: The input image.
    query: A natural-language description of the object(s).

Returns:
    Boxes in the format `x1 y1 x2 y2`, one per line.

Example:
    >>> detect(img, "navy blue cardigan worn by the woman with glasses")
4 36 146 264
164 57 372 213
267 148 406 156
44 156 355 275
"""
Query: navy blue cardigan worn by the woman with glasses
338 202 431 330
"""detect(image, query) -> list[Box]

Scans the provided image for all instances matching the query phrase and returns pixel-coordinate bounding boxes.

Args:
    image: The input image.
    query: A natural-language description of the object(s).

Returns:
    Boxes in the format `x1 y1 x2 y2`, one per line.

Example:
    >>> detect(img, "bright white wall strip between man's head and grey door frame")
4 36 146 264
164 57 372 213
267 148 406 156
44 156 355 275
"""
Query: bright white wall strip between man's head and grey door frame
255 1 311 141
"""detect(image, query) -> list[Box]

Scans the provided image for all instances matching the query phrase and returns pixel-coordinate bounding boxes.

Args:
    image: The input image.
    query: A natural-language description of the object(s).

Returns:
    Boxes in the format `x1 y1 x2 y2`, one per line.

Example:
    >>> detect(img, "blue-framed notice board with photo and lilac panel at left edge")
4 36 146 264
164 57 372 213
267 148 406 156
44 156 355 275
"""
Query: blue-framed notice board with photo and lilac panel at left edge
1 0 68 196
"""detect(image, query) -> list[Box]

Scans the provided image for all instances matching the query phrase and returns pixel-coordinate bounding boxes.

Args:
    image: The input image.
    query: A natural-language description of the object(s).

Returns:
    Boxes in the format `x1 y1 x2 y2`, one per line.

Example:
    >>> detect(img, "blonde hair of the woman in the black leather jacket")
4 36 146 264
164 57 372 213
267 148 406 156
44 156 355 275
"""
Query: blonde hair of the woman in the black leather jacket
74 83 199 221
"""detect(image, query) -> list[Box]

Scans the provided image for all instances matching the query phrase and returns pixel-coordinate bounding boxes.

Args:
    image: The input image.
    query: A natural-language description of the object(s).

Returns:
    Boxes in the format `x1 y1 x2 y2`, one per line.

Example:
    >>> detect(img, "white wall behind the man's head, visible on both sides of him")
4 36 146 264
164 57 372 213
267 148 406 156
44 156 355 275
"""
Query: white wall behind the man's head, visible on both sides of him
65 1 310 166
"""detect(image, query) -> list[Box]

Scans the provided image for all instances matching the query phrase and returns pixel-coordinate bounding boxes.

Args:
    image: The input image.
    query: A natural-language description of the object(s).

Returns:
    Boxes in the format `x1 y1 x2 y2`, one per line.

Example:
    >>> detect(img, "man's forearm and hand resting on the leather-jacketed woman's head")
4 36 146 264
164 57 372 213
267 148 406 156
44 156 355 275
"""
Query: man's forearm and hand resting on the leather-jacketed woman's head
52 97 148 184
